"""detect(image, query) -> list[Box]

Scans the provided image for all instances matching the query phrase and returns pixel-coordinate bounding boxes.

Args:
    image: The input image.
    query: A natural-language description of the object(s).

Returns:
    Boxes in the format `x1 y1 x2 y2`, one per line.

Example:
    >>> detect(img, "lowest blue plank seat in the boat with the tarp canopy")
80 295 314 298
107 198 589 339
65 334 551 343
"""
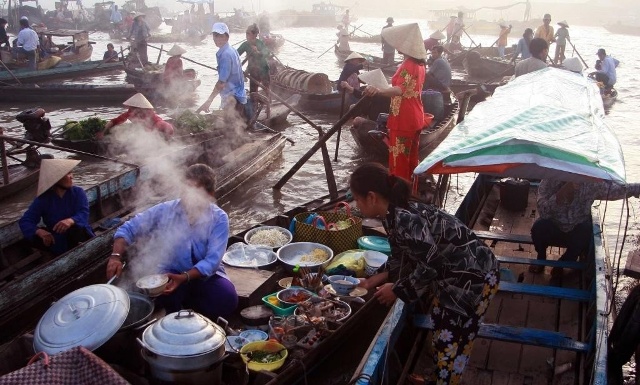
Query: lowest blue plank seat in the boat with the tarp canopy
413 314 591 352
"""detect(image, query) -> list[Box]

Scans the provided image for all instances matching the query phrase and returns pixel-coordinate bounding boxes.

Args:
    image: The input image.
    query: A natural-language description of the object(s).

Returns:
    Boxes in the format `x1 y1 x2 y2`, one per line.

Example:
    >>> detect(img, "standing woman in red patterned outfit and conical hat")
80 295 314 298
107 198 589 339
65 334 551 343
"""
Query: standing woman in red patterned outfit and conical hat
364 23 427 188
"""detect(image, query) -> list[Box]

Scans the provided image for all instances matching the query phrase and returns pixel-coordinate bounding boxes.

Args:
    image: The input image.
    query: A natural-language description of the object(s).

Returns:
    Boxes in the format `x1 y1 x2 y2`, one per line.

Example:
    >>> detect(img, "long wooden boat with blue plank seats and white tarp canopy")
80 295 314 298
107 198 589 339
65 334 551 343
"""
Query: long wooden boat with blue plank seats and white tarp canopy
354 68 625 385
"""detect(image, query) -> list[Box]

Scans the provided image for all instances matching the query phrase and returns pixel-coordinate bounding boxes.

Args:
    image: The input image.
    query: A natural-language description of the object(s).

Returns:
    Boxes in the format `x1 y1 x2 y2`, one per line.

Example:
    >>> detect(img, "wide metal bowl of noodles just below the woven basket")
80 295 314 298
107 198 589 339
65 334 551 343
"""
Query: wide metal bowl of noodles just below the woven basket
278 242 333 272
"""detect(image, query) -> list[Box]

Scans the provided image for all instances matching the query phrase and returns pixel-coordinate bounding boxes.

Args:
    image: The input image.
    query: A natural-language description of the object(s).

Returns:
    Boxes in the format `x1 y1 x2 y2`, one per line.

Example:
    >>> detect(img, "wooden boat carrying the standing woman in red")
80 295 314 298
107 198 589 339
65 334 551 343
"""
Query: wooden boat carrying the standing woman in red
350 98 468 160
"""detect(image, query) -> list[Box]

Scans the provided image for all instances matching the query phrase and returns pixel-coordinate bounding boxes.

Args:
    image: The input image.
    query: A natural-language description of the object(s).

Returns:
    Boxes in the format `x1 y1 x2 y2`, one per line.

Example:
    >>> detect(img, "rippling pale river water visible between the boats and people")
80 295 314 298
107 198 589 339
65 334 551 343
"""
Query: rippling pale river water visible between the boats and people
0 18 640 288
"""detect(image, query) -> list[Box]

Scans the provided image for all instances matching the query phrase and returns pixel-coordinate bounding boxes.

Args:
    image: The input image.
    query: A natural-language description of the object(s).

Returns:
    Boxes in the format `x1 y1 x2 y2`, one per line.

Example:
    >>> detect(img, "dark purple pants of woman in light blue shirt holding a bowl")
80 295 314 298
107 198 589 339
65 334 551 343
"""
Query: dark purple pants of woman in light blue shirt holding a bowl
156 275 238 322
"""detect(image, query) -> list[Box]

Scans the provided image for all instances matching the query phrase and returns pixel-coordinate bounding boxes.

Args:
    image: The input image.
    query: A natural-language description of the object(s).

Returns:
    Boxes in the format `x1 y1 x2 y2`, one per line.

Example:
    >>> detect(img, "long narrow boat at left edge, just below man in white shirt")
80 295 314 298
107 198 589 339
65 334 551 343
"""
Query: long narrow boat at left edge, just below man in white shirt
0 60 123 84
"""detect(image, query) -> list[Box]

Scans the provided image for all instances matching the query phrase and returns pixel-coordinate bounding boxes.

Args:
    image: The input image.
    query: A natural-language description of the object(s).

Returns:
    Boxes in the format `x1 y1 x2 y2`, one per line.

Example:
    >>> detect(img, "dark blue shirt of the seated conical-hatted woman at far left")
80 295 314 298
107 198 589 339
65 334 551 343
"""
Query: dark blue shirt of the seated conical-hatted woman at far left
18 186 95 255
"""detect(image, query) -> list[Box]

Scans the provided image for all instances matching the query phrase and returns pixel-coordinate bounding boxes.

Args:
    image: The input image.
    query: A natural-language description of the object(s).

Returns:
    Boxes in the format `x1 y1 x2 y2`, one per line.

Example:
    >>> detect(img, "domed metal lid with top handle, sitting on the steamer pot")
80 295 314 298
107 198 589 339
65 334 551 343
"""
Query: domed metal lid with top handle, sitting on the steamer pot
142 310 226 357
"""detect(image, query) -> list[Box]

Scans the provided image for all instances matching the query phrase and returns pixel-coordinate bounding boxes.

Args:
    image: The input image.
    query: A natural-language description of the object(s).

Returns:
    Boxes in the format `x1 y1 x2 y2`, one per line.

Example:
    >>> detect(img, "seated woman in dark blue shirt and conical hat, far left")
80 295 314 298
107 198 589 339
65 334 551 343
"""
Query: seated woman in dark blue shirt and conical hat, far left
18 159 95 255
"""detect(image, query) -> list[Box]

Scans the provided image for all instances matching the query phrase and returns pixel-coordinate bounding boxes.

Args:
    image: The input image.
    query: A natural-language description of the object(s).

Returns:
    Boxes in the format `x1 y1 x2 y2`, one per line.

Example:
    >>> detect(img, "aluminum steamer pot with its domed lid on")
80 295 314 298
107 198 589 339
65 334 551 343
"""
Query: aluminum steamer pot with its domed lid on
138 310 226 372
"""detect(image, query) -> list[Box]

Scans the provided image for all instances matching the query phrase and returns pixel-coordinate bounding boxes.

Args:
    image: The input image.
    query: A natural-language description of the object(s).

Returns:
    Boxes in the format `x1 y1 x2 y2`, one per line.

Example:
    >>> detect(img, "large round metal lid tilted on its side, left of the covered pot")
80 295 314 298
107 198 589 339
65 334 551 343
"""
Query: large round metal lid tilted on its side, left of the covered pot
33 284 130 354
